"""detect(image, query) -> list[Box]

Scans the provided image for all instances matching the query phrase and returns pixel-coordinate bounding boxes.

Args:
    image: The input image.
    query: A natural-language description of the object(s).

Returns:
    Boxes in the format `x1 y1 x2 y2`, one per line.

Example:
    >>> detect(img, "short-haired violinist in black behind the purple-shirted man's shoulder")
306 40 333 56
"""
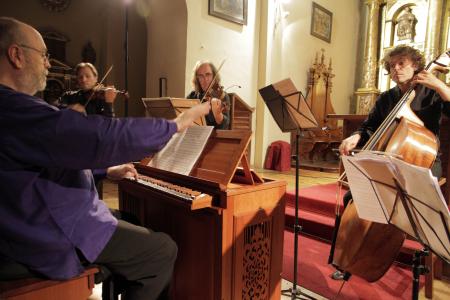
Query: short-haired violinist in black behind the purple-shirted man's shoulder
60 62 117 117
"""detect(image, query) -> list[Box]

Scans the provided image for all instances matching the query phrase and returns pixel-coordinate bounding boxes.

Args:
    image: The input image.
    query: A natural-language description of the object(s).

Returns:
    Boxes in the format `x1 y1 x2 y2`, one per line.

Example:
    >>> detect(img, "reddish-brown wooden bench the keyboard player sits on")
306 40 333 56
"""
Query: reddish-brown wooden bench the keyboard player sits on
0 267 99 300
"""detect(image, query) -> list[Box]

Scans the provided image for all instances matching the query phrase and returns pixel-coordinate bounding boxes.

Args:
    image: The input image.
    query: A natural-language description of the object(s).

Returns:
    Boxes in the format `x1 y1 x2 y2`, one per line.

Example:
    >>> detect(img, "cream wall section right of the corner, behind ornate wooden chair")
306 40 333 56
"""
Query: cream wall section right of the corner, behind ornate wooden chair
255 0 360 166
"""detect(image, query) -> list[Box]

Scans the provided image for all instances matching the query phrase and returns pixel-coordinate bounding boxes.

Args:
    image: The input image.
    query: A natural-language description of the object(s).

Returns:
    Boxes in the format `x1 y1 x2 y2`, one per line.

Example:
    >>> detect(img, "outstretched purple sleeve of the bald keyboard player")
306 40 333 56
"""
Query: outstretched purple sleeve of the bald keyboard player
0 97 177 169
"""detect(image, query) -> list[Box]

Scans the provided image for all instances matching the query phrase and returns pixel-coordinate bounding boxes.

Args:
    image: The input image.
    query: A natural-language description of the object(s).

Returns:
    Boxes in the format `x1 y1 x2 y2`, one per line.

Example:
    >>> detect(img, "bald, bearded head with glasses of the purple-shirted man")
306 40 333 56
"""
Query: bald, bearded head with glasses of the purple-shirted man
0 17 50 95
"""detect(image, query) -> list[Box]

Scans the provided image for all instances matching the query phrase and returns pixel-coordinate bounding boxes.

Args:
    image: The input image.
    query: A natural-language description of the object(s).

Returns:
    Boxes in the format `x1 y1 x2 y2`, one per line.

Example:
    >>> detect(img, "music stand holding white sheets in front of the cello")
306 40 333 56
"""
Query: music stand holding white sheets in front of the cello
343 152 450 299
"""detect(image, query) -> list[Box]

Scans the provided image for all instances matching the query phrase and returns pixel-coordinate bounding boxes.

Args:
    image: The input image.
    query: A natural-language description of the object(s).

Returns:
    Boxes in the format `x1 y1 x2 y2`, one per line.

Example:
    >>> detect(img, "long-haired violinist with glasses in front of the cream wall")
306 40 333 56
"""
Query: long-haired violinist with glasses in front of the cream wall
186 61 230 129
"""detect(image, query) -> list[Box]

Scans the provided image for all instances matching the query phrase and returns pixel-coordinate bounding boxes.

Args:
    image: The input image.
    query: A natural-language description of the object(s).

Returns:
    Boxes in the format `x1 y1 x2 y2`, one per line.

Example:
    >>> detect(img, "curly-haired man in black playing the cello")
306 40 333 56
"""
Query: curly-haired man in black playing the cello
331 45 450 280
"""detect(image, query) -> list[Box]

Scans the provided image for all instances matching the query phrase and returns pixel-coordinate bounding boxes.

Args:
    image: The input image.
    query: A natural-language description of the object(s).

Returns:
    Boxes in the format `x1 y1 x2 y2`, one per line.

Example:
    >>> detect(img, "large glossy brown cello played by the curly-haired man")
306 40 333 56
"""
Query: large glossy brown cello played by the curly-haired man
330 50 450 282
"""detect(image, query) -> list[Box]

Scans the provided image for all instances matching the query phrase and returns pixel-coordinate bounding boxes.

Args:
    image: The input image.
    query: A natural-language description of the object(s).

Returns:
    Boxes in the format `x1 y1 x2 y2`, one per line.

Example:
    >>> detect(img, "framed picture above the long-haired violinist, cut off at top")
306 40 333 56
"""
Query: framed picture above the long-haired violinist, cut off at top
208 0 247 25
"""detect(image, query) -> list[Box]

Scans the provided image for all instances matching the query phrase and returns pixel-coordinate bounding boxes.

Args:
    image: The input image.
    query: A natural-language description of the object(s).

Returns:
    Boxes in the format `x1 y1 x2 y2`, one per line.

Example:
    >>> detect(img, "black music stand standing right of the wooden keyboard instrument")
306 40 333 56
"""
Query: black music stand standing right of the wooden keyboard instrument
259 78 318 299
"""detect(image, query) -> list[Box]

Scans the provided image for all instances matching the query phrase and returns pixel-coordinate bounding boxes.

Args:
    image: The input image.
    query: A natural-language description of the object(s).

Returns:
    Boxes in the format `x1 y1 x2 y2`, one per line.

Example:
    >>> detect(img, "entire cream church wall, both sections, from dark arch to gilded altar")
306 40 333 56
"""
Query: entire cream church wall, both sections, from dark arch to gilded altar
181 0 361 166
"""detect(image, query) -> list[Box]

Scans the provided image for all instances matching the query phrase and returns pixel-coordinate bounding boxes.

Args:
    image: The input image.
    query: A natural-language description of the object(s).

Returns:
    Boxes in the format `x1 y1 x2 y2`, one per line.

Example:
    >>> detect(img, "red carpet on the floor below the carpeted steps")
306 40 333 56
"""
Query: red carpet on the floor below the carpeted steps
282 230 424 300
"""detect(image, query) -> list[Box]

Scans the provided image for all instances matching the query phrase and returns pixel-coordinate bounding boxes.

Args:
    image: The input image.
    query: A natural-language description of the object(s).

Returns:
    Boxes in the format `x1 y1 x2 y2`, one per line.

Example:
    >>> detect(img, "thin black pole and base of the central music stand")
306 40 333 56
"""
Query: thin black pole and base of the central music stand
282 129 313 300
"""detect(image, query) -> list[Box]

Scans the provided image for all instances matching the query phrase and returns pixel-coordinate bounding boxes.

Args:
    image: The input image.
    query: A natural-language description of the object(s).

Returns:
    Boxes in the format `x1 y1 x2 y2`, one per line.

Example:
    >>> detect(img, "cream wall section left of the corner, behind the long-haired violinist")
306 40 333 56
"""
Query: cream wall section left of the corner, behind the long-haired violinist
185 0 260 162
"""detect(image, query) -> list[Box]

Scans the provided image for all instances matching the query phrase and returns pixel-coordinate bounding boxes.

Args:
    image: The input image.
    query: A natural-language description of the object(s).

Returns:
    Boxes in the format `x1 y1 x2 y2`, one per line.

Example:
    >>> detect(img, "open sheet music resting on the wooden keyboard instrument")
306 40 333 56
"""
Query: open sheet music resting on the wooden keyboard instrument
148 126 214 175
